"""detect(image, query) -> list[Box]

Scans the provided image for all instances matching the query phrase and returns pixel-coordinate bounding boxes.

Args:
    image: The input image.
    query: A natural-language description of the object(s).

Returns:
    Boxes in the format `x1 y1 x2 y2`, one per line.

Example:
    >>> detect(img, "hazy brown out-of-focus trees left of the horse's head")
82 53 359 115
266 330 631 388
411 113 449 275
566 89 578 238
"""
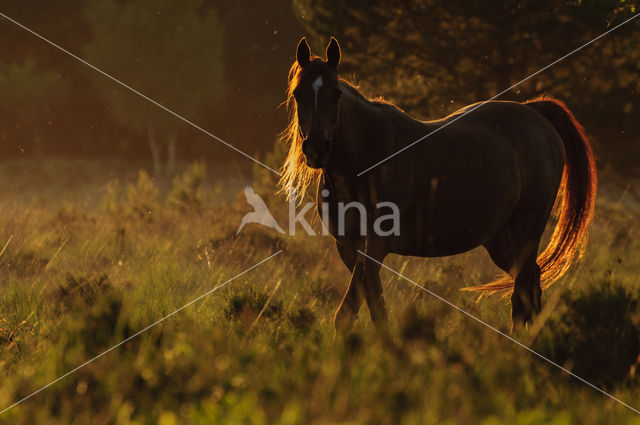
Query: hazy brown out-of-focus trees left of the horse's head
0 0 302 168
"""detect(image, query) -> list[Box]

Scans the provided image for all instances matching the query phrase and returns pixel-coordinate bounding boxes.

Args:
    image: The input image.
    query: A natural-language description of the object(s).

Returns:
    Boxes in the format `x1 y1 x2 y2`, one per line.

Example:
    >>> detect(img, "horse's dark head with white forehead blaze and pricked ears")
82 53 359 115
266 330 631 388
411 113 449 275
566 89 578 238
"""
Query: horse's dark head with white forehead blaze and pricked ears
293 37 342 168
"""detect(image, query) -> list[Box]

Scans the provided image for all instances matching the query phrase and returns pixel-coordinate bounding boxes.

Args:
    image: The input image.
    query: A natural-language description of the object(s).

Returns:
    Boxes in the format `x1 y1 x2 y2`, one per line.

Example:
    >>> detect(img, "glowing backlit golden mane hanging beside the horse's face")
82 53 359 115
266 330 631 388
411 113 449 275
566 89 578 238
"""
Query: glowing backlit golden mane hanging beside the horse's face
278 56 382 201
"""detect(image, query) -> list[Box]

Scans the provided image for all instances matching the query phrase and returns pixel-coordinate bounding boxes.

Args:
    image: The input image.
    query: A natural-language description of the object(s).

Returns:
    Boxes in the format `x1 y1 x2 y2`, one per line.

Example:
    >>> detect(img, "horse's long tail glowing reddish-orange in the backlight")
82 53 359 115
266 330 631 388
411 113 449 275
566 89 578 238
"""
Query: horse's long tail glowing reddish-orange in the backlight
469 98 598 294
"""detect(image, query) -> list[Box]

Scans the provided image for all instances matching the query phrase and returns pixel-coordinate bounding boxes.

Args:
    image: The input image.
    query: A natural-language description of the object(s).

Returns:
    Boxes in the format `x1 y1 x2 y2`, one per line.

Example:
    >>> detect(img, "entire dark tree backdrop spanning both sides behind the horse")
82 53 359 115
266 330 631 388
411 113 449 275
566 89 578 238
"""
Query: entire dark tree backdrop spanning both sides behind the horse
0 0 640 171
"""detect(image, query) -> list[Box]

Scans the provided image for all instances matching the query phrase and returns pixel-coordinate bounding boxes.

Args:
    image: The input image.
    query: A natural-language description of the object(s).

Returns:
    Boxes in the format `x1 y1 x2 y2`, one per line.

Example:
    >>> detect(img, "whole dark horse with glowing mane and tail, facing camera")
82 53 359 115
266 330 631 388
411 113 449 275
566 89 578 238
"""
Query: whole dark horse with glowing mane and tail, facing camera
279 37 597 331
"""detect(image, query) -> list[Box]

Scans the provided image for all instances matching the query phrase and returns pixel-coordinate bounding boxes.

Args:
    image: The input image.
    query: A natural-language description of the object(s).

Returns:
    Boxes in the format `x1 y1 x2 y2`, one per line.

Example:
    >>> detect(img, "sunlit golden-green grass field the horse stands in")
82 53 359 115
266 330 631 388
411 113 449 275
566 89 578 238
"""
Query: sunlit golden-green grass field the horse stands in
0 160 640 425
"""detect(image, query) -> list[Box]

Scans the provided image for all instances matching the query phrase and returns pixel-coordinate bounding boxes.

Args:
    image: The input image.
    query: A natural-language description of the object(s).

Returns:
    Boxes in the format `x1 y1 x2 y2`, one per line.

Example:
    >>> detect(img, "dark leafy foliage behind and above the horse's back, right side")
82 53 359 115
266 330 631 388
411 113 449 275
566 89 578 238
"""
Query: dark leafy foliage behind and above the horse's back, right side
294 0 640 143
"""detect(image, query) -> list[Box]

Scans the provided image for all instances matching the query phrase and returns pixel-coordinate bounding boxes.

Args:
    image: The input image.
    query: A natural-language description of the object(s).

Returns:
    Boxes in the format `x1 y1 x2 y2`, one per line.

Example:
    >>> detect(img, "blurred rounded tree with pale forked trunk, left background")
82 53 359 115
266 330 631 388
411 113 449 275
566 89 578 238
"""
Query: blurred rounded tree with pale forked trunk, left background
84 0 223 176
